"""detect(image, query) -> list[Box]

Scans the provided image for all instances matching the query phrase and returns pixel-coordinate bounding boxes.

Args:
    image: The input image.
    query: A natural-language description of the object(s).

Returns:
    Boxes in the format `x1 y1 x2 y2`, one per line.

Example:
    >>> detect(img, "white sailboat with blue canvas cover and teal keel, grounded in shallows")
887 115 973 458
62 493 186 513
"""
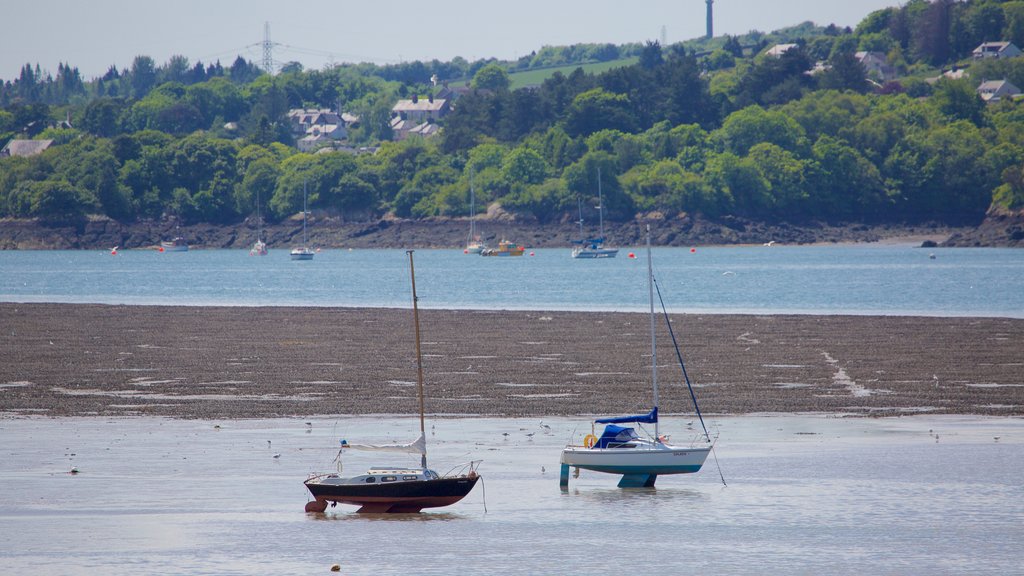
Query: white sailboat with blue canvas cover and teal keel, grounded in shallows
559 227 713 488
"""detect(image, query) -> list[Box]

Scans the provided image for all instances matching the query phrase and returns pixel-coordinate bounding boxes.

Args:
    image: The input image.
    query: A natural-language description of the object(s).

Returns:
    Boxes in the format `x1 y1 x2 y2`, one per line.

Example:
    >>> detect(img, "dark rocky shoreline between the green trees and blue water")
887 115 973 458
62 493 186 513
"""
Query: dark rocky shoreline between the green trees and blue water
0 212 995 250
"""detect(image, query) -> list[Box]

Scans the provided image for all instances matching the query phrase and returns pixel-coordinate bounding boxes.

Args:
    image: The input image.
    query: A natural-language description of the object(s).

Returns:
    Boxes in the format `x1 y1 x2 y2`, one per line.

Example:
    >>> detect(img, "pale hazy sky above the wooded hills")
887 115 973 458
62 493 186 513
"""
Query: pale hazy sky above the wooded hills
0 0 900 80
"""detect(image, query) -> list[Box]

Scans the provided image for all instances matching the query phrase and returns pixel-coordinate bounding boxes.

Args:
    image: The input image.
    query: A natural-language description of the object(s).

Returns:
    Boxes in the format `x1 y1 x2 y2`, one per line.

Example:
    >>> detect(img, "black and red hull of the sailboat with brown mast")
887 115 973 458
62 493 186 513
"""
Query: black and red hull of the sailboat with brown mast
305 476 479 512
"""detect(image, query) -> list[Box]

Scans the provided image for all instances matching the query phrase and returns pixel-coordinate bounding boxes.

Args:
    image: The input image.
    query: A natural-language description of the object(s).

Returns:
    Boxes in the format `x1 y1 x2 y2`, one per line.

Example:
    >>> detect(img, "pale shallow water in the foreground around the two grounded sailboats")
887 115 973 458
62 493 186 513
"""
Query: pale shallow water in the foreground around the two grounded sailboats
0 416 1024 576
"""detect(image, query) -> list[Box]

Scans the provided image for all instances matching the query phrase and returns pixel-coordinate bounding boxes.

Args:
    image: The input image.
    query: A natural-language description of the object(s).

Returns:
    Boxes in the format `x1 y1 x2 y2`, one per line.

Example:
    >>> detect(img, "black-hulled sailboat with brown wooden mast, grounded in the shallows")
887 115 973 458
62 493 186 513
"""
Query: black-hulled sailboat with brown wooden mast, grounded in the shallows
305 250 480 512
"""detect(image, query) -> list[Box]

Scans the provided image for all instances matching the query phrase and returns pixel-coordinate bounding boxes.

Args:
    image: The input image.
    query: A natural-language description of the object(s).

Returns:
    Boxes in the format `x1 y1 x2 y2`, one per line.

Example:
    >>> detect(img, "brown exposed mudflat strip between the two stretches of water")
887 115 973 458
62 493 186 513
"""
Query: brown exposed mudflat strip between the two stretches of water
0 303 1024 418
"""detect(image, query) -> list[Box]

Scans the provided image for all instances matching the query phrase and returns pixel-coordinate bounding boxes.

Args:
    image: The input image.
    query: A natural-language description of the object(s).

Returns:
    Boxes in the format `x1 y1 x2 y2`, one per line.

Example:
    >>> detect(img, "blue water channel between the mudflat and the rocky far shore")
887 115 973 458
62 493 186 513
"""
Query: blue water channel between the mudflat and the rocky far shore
0 245 1024 318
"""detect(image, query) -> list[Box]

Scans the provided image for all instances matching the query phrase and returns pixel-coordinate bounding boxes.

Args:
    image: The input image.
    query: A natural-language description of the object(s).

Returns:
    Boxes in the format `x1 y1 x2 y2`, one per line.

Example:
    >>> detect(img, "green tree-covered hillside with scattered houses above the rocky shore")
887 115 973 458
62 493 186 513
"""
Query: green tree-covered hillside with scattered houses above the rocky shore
0 0 1024 233
